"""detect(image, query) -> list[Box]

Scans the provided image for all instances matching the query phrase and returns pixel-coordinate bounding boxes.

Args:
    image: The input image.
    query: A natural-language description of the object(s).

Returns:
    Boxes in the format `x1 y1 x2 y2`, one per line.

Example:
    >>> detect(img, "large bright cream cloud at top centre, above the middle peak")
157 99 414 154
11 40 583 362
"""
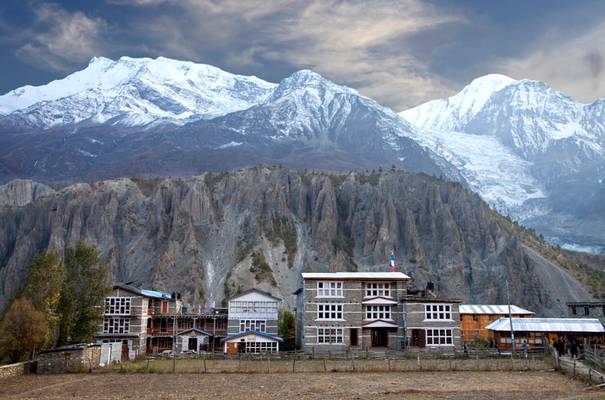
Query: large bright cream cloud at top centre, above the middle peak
266 0 465 110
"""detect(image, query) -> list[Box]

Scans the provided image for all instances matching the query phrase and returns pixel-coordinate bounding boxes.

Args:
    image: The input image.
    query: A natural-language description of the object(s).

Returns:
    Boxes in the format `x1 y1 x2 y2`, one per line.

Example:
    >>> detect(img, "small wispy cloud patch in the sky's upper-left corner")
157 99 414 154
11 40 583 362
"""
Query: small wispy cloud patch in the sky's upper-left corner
16 3 107 71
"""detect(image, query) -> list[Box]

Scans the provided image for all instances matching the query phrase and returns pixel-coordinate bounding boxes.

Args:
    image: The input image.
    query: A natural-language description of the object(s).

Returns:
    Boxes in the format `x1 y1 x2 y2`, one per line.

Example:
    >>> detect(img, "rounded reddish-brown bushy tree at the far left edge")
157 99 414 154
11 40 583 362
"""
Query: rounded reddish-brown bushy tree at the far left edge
0 297 48 362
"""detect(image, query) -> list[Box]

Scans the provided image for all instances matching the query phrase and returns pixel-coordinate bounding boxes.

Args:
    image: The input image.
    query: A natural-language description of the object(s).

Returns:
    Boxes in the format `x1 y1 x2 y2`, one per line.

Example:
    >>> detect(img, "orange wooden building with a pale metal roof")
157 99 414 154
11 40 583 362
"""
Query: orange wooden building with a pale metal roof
460 304 534 344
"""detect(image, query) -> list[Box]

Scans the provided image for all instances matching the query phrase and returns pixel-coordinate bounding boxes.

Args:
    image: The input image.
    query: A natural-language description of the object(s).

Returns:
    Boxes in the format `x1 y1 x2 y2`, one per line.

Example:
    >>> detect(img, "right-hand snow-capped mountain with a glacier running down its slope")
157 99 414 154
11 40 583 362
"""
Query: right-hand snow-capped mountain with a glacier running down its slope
400 75 605 249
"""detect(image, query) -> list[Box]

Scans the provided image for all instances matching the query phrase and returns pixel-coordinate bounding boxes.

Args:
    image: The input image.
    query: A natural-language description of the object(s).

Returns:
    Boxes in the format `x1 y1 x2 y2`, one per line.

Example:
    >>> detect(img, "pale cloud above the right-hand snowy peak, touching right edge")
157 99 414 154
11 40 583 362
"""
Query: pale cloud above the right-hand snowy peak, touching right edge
492 23 605 103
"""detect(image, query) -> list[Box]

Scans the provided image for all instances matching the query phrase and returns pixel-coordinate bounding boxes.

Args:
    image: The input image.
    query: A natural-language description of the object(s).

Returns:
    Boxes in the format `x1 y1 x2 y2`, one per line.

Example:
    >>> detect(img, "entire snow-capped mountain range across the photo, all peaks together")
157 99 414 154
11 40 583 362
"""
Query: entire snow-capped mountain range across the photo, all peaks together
0 57 605 252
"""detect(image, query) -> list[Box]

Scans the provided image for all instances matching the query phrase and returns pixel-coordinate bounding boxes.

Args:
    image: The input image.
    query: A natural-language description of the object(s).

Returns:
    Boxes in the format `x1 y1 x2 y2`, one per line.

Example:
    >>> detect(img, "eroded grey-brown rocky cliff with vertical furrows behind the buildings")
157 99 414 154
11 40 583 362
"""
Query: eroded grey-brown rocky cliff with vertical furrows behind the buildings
0 166 600 315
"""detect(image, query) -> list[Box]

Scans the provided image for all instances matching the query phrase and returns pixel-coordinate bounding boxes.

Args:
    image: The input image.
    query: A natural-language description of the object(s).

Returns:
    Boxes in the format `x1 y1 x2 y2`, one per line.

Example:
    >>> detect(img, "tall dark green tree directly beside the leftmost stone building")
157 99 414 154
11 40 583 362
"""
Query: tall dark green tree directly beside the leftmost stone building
59 241 109 344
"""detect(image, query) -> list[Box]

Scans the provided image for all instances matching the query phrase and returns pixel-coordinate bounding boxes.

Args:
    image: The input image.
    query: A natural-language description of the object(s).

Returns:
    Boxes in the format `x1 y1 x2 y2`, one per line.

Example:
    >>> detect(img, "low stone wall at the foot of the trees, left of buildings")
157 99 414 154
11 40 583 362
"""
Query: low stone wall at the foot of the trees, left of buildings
37 346 101 374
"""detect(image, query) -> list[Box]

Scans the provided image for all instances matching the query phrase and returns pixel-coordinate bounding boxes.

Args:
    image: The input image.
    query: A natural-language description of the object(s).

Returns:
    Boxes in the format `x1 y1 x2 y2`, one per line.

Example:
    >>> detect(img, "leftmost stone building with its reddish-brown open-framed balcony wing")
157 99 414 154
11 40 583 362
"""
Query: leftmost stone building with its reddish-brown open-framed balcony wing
97 284 227 359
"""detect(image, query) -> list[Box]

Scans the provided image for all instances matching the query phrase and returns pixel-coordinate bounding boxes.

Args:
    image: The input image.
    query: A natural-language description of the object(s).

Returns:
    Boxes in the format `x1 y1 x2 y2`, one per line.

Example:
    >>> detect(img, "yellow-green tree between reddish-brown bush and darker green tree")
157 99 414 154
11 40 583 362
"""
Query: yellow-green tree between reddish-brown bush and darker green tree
22 251 65 346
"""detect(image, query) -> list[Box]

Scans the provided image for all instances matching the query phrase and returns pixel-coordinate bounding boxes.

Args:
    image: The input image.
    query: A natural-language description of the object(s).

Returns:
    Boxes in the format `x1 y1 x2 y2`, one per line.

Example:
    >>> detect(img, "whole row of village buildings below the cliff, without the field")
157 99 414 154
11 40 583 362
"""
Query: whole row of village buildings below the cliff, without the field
16 272 605 372
